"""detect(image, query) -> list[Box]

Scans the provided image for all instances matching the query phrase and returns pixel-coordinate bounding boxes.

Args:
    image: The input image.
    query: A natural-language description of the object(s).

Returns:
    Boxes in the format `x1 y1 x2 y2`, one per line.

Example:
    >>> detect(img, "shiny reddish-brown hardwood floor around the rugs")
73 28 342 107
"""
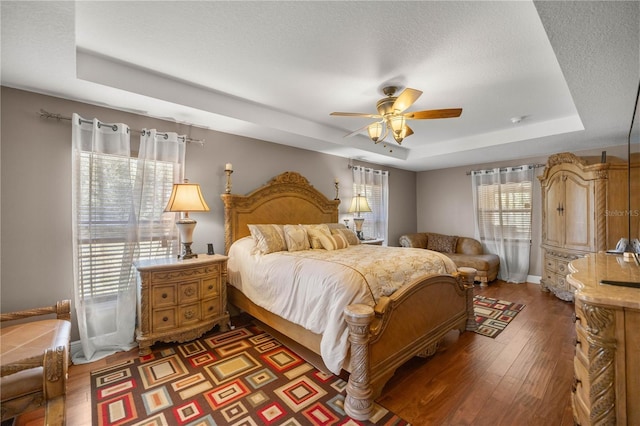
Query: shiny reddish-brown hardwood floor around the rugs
13 281 575 426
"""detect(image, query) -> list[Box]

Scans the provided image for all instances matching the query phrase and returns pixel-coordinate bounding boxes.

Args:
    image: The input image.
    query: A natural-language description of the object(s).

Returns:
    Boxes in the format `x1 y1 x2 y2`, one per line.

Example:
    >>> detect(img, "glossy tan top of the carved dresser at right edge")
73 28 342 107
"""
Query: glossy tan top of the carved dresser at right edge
567 252 640 310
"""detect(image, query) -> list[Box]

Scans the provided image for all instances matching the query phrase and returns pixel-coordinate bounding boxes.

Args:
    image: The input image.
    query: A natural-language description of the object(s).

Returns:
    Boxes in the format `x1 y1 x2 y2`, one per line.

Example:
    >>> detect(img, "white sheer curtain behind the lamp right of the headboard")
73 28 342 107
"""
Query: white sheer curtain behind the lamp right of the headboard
351 166 389 241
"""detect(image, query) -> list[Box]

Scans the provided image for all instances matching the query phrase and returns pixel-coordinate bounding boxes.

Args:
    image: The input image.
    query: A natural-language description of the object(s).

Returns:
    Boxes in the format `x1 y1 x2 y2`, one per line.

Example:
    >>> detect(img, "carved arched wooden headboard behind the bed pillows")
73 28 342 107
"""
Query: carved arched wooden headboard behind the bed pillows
220 172 340 253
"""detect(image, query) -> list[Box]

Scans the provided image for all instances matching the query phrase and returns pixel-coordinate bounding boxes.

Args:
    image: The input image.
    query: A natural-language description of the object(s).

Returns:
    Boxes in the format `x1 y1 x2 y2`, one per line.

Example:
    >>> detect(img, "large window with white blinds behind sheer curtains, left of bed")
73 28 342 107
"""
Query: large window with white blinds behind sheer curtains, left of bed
76 151 177 298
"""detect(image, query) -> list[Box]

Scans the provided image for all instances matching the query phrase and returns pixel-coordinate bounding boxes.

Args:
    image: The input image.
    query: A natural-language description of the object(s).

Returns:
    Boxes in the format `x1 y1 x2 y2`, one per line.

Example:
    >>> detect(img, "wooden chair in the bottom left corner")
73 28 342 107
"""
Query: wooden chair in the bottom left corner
0 300 71 425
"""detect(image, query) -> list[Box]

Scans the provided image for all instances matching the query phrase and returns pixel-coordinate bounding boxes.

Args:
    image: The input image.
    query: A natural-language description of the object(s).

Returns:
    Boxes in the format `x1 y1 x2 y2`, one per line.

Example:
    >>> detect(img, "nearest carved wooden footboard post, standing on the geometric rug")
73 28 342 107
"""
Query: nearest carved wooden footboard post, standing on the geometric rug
344 304 373 421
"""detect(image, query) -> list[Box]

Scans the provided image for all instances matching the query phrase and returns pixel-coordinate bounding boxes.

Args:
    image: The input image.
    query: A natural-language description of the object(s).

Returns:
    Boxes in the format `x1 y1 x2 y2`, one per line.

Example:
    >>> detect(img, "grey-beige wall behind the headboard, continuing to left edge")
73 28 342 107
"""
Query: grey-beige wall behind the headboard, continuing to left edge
0 87 416 338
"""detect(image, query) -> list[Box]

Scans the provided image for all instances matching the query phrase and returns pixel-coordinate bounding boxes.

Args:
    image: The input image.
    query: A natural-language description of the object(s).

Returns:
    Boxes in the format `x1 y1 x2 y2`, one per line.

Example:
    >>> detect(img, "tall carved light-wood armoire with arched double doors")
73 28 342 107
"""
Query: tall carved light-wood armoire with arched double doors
538 152 640 301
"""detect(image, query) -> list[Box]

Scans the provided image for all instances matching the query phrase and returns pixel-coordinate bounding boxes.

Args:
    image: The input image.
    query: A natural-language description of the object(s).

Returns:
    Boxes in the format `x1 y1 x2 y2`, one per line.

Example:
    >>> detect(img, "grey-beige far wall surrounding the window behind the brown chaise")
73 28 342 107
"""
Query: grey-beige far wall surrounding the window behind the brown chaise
416 145 627 280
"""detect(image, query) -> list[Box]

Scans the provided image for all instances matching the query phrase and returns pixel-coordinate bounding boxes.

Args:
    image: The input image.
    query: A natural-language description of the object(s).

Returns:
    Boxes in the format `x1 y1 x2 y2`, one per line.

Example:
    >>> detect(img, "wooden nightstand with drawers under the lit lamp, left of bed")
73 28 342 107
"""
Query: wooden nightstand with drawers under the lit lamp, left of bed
134 254 229 355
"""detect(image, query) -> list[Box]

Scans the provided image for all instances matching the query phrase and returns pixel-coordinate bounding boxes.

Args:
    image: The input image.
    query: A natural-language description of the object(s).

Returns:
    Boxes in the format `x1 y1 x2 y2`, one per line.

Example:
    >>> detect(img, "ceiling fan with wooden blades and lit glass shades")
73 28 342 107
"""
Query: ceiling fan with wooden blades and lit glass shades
330 86 462 145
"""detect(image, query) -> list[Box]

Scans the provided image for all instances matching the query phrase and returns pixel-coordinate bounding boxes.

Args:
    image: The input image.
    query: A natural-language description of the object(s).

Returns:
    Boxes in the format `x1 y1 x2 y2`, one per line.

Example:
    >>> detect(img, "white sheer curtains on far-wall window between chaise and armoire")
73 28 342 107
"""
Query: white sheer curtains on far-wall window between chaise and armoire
471 166 534 283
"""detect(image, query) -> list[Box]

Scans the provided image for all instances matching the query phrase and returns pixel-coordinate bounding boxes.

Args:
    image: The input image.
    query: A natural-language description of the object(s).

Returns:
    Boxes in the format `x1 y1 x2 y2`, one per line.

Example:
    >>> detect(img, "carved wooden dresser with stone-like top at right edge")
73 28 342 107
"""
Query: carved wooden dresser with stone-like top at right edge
567 253 640 426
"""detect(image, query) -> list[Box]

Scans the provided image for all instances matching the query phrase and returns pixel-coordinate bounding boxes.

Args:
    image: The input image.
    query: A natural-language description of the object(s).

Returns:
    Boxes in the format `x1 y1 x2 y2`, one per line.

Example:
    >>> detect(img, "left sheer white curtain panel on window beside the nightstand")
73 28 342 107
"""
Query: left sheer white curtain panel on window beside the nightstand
72 114 136 363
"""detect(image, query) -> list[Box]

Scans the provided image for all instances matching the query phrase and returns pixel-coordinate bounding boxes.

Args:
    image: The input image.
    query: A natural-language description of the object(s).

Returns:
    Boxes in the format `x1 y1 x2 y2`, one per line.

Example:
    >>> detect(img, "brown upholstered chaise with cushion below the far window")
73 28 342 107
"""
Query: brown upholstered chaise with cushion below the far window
400 232 500 286
